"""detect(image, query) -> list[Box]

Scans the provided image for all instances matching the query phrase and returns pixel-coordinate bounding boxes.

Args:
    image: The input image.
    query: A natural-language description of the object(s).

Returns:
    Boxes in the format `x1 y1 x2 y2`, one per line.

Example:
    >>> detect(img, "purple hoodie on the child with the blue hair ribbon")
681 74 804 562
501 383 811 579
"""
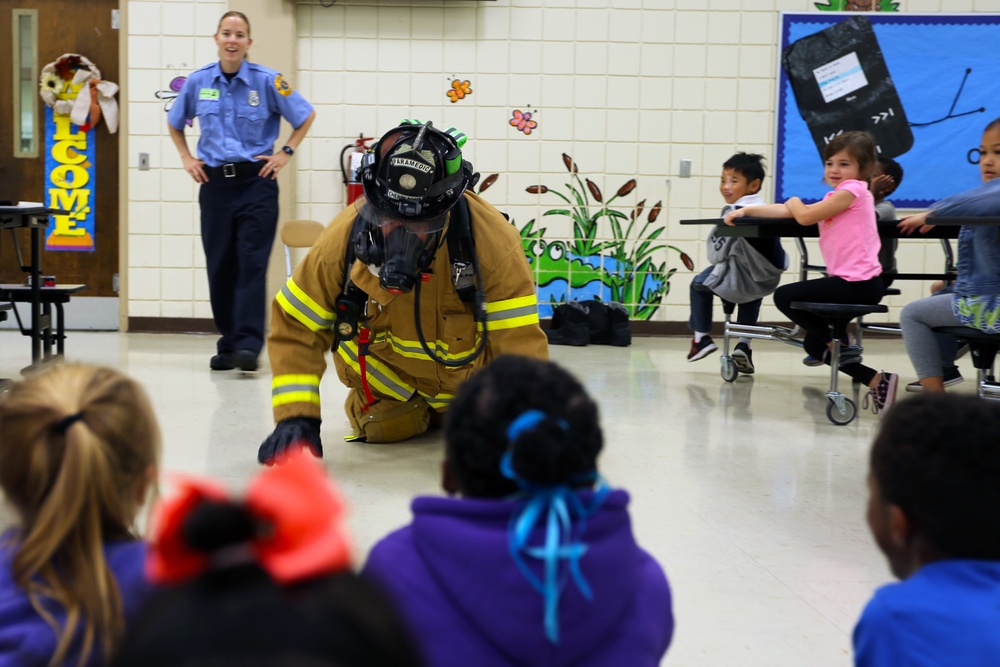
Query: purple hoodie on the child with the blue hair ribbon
364 491 674 667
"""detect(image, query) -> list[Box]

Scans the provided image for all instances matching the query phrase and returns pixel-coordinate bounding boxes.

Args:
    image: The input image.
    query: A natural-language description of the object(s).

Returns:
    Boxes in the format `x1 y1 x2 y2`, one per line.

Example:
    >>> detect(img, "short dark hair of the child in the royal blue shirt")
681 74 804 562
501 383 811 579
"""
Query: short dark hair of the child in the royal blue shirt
871 393 1000 560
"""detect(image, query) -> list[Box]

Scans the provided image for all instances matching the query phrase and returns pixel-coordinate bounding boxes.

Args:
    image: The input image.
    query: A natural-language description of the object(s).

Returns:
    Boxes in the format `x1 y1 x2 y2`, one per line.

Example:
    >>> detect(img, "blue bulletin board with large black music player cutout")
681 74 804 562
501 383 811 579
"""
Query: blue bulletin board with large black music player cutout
774 12 1000 208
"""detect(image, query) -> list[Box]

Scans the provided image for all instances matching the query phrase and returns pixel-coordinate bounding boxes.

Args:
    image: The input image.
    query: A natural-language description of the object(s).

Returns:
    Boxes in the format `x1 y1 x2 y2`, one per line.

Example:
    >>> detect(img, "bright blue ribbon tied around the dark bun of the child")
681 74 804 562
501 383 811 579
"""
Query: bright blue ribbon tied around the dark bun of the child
500 410 610 644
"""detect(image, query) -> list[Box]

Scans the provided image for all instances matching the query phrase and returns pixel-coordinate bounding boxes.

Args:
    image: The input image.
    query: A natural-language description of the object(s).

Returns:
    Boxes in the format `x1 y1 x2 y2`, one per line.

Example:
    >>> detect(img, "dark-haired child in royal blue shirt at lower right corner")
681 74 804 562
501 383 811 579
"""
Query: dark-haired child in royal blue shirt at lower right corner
854 393 1000 667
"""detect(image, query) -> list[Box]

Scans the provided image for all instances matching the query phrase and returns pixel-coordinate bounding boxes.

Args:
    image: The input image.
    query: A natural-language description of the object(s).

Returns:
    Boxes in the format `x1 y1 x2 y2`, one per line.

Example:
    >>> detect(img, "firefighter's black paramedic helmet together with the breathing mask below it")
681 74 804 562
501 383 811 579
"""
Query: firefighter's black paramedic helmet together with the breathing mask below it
351 121 475 294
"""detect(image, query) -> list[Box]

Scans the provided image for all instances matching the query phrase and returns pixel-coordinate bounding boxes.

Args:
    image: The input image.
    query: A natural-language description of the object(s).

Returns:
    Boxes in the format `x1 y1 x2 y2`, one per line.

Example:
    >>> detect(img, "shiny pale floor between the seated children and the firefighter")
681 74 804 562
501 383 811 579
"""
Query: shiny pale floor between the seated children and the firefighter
0 332 972 667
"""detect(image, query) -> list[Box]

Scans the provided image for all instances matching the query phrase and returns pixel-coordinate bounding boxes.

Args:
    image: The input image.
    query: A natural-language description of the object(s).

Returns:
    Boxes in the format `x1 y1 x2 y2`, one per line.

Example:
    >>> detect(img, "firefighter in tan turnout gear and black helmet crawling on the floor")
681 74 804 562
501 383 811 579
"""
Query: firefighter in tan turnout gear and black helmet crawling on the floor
258 121 548 463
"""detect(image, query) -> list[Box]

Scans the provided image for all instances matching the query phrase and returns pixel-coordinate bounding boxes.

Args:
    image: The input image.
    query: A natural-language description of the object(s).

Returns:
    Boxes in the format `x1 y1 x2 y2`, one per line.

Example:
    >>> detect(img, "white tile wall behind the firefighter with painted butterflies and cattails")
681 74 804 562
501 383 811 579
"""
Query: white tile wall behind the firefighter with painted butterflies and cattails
129 0 1000 321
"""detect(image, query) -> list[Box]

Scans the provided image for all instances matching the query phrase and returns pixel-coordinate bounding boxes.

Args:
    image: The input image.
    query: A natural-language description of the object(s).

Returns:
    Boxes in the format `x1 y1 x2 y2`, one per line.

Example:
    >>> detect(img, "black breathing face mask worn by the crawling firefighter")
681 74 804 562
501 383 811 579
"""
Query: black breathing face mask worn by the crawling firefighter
352 198 447 294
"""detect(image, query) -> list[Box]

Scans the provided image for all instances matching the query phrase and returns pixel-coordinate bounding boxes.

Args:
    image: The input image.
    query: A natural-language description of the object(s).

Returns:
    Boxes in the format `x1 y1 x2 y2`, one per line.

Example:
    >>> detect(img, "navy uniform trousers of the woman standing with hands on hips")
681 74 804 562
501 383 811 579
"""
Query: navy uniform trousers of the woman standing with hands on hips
198 173 278 354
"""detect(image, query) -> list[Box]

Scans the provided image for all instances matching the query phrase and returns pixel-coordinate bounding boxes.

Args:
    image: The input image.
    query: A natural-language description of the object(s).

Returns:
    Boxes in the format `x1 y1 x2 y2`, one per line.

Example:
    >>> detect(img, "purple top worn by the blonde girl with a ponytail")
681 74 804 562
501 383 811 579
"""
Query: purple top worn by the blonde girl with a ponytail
0 532 150 667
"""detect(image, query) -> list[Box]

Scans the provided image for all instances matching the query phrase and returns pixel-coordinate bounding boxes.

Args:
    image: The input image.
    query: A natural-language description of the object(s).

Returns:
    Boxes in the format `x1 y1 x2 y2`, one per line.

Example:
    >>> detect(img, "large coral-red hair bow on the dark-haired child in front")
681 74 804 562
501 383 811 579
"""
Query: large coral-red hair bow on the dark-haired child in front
146 448 351 584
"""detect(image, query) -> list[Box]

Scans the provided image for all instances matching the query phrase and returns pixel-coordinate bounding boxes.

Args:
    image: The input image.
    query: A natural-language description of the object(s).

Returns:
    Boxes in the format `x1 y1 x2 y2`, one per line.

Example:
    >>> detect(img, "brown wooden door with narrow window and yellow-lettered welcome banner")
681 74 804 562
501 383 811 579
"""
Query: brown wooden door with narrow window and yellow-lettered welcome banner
0 0 122 328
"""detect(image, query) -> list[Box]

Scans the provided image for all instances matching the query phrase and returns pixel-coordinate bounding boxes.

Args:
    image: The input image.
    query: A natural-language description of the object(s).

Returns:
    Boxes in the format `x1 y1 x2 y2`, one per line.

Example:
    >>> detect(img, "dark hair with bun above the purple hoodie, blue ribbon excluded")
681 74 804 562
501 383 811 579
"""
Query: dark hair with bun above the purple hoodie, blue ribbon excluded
445 355 604 498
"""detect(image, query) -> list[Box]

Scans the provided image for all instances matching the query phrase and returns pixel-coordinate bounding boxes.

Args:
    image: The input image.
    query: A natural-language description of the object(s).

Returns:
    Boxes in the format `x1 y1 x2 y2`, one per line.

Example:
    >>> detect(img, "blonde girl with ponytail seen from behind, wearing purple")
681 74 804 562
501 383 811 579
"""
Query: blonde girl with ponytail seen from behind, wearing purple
0 364 160 667
